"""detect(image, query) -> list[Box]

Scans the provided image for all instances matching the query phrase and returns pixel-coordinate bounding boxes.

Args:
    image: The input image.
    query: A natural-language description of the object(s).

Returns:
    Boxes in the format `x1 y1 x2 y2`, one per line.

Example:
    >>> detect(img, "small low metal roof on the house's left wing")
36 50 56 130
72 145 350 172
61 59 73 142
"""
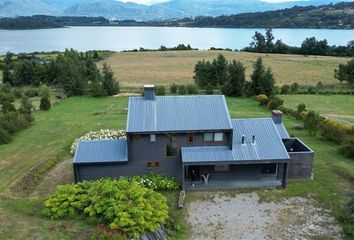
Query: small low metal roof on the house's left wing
73 140 128 164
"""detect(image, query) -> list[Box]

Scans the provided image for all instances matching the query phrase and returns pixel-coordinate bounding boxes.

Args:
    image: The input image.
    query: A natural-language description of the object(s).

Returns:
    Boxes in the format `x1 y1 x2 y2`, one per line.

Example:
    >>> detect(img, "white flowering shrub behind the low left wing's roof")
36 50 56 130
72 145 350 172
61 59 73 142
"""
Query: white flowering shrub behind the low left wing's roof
70 129 127 155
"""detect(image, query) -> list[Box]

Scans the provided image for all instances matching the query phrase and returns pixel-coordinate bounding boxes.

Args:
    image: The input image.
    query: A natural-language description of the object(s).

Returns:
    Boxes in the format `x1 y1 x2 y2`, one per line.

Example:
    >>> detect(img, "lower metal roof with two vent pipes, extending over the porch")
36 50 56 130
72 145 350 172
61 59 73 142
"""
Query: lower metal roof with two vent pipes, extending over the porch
182 118 290 163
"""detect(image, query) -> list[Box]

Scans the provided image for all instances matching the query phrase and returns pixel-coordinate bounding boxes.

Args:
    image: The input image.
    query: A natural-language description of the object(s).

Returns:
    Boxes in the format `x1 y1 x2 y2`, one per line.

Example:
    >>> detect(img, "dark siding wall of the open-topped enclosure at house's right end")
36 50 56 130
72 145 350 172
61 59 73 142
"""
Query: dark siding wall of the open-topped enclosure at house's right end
288 152 314 179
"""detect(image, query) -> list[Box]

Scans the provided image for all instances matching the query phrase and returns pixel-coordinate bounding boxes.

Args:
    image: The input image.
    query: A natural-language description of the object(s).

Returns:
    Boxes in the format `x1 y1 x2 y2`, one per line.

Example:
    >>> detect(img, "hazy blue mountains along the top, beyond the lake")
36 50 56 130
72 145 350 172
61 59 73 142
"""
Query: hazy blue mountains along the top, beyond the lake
0 0 352 21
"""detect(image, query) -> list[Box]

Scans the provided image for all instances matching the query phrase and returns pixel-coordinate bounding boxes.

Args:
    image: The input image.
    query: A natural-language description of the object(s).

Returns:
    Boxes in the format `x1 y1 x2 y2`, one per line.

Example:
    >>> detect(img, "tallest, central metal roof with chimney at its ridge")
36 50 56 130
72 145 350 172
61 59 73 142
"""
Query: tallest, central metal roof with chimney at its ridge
127 95 232 132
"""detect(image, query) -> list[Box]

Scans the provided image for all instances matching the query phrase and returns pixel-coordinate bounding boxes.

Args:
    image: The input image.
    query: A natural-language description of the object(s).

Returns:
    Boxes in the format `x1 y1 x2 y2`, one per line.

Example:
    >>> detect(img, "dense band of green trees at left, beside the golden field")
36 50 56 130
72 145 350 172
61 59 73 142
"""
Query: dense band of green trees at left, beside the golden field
2 49 119 97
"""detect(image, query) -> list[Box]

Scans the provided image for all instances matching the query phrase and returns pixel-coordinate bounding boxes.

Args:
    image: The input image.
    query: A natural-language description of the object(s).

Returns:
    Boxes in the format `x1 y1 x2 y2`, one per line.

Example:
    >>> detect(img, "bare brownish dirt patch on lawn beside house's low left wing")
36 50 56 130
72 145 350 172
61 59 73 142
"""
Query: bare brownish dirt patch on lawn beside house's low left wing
30 158 74 197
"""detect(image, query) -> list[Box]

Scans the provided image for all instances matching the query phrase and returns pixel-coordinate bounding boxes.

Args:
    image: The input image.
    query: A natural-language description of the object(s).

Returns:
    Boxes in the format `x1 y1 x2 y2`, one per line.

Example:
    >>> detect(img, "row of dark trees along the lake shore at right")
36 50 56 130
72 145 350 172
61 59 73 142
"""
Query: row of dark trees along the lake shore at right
243 28 354 56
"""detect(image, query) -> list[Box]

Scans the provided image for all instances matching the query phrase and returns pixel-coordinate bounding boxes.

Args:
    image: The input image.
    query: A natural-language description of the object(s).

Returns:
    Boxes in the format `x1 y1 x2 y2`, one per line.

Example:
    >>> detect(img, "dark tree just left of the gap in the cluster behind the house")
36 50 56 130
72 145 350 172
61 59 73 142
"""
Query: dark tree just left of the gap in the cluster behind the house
223 60 246 97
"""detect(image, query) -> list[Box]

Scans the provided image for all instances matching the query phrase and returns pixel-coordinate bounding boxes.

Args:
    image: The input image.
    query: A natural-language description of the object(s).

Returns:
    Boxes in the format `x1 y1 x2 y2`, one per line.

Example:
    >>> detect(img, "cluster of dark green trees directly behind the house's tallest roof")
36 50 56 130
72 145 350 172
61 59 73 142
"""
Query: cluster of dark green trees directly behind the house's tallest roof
194 54 275 97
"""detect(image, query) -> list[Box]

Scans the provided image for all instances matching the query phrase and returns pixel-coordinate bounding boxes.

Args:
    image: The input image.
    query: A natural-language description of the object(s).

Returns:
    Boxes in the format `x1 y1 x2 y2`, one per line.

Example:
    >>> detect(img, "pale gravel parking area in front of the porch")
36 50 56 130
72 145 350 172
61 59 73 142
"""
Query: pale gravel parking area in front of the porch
187 192 342 240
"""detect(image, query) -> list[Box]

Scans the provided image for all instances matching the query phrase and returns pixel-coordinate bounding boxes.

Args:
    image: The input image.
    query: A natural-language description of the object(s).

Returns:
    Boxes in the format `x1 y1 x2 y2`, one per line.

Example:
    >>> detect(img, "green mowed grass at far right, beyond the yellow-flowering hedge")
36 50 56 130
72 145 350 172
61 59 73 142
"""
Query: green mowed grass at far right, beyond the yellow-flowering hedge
280 95 354 124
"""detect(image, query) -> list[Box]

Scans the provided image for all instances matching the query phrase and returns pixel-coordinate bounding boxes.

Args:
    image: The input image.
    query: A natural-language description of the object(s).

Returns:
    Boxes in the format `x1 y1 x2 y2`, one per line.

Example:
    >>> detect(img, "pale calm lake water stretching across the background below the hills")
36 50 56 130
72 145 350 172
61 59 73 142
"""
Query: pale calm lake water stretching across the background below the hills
0 27 354 54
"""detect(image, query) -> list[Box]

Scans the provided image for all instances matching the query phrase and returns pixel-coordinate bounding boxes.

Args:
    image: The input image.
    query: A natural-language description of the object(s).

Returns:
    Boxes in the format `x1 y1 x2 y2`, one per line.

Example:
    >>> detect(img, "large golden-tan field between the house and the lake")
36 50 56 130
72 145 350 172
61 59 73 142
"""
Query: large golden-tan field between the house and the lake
105 51 348 88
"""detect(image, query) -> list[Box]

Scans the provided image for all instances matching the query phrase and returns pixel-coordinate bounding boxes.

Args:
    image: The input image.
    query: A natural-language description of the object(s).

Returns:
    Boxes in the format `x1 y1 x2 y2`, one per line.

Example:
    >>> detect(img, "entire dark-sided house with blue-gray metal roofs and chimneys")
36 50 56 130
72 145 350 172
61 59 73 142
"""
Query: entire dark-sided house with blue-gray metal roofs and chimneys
73 85 314 189
